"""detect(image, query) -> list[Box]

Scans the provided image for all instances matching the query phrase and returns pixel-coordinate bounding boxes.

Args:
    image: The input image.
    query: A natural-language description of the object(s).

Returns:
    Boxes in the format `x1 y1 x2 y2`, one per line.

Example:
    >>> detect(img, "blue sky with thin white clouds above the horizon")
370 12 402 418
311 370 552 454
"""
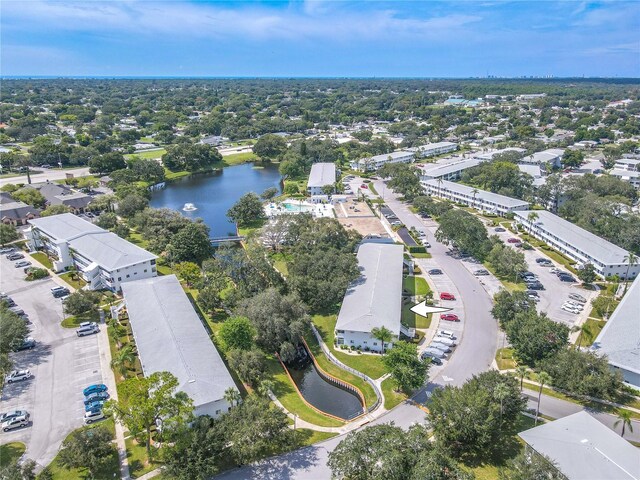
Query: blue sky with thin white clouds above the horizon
0 0 640 77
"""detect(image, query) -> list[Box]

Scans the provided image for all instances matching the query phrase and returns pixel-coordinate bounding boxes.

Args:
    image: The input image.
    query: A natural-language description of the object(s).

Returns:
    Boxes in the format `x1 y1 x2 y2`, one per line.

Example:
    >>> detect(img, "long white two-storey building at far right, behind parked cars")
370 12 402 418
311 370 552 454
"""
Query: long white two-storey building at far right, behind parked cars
514 210 640 278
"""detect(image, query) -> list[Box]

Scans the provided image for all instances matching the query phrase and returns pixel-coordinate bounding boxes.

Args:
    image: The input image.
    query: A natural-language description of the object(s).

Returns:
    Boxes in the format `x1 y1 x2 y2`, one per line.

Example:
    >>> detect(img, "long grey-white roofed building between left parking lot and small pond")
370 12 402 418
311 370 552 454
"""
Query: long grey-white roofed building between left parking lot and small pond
122 275 237 418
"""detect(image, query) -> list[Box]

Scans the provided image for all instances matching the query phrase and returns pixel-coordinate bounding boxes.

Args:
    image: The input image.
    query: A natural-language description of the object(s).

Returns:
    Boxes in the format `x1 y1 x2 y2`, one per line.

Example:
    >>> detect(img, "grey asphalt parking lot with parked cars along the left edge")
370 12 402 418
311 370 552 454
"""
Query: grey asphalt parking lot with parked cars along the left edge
0 255 102 466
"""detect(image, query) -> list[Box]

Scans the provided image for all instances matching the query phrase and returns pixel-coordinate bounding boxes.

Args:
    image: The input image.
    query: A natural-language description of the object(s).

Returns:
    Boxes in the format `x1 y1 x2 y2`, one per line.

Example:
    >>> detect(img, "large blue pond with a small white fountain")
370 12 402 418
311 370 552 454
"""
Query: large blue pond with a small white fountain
150 163 282 237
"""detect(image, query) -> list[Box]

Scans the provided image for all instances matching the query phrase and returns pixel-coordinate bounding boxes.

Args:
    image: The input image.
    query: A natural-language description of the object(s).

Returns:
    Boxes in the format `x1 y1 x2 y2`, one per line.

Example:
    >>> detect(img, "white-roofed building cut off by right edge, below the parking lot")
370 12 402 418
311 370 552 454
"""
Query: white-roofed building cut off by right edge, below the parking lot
591 276 640 390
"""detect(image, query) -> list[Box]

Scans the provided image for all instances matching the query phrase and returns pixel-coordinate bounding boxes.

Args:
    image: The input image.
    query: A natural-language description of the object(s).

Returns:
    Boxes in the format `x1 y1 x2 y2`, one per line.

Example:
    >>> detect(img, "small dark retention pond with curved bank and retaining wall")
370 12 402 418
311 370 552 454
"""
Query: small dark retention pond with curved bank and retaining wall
289 362 362 420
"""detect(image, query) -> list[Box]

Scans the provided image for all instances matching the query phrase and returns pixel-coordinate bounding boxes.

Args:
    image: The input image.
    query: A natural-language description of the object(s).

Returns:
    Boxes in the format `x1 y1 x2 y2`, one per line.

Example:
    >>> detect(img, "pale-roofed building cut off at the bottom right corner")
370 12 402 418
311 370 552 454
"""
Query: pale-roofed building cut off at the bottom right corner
518 411 640 480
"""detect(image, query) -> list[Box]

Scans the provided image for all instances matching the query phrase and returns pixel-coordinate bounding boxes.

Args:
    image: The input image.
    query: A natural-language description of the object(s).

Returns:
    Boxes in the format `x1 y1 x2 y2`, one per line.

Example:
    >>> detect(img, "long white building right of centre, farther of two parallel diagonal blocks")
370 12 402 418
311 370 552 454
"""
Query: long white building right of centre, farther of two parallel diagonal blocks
421 179 529 215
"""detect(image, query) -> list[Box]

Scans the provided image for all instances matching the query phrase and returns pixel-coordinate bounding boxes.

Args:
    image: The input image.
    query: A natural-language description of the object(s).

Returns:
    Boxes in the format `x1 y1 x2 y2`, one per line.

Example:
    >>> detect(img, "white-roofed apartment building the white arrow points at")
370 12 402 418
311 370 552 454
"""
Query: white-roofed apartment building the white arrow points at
335 241 404 352
